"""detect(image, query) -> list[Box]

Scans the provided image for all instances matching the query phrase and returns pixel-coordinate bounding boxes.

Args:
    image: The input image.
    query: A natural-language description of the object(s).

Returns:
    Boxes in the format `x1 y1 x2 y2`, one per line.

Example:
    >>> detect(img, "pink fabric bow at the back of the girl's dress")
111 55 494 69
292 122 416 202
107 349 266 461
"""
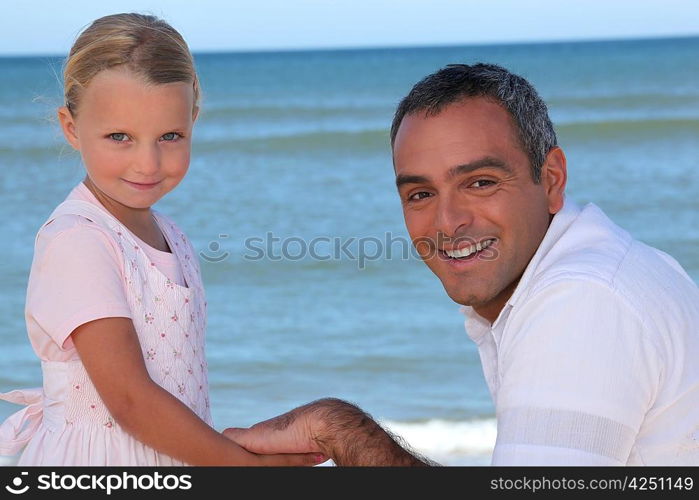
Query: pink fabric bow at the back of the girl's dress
0 388 44 455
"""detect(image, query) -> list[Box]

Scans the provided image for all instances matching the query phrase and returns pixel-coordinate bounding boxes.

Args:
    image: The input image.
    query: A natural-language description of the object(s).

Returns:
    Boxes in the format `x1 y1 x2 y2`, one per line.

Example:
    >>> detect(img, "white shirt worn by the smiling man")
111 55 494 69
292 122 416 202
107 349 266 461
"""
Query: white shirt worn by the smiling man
461 196 699 465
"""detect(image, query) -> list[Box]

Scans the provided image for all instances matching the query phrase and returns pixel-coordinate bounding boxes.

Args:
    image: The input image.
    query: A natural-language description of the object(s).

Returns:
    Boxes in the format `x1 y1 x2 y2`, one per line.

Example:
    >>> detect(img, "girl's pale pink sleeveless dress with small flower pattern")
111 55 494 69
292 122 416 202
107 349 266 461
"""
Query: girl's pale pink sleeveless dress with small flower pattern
0 185 212 466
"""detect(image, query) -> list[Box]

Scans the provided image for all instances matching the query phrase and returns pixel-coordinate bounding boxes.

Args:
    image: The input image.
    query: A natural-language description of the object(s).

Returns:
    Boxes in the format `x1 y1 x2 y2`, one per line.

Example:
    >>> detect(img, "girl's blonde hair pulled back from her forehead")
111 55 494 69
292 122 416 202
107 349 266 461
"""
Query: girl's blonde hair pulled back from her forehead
63 13 200 115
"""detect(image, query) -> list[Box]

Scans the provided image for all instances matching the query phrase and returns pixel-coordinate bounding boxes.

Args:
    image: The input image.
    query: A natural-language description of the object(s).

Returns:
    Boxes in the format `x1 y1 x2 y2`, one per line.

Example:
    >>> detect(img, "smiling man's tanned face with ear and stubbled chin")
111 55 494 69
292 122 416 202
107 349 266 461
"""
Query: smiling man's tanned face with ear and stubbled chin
393 98 565 321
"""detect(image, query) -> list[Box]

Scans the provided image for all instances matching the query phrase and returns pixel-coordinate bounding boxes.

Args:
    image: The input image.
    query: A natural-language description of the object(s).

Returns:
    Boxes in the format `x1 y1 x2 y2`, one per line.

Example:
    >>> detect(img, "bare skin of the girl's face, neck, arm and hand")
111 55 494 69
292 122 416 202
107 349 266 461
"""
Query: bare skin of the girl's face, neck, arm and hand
58 68 325 466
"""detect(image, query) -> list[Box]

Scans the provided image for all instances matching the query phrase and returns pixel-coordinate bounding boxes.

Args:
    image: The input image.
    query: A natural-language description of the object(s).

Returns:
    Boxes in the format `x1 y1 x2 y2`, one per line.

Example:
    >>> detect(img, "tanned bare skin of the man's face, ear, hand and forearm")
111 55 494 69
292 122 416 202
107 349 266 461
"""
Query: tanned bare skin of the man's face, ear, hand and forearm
224 97 567 466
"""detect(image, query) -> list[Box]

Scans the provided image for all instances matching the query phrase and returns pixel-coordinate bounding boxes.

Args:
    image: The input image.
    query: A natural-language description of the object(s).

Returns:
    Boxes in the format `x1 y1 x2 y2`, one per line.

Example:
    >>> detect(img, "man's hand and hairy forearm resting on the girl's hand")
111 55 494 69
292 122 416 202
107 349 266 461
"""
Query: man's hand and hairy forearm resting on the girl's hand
223 398 437 466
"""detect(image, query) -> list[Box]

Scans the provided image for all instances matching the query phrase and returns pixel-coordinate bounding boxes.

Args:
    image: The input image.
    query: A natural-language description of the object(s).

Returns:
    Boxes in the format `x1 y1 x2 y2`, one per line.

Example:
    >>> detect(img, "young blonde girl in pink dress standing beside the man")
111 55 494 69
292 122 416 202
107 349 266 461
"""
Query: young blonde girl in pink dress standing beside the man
0 10 324 466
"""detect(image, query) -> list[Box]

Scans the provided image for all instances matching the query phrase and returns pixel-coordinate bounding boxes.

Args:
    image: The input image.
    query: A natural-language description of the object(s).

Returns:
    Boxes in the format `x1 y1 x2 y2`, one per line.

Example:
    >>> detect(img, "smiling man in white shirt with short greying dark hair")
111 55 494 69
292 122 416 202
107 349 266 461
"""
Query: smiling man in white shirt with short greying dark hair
225 64 699 465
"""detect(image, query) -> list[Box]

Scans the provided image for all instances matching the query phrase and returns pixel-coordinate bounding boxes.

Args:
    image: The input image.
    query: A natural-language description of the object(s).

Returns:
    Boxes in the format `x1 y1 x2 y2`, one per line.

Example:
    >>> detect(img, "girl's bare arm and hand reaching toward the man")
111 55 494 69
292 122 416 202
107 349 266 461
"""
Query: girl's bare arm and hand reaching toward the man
72 318 325 466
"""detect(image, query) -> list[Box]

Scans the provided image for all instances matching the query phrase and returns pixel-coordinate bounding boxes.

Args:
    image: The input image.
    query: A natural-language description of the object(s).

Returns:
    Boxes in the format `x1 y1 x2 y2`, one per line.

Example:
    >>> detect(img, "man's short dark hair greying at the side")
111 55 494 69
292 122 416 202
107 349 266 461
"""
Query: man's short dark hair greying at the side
391 63 557 183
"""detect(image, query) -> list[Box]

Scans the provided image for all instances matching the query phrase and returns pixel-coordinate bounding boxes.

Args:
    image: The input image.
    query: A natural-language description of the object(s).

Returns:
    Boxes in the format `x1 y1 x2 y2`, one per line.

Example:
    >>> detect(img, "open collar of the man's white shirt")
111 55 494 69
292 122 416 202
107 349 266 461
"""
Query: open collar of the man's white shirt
459 197 581 332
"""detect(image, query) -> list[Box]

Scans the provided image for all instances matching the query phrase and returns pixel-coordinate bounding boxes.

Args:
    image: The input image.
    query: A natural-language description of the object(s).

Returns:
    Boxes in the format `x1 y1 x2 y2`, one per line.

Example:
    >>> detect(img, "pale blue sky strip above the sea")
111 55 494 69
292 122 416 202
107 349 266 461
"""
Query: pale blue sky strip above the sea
0 0 699 55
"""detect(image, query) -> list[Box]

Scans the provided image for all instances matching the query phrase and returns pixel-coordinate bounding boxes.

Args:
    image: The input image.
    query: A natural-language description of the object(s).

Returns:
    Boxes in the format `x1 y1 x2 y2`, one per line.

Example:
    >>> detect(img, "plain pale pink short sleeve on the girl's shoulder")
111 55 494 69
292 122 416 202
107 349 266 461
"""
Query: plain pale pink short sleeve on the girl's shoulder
27 221 132 351
